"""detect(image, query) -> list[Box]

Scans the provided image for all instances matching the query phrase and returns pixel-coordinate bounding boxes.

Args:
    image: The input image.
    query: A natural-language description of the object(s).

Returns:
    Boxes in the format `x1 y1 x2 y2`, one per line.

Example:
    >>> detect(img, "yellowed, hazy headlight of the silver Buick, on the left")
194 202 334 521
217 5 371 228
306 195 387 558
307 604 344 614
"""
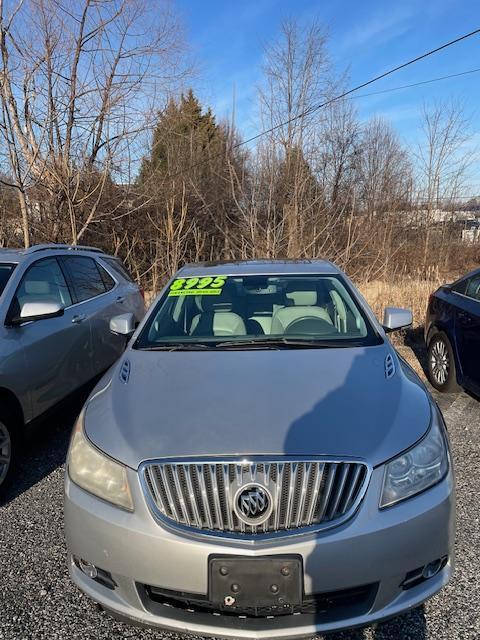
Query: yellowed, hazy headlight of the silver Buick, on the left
67 411 133 511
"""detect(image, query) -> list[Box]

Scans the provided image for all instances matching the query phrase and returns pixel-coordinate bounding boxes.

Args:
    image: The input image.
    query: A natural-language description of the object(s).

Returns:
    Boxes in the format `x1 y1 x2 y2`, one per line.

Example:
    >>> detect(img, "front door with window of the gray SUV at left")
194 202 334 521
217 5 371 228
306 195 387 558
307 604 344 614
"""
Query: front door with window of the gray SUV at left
9 257 93 417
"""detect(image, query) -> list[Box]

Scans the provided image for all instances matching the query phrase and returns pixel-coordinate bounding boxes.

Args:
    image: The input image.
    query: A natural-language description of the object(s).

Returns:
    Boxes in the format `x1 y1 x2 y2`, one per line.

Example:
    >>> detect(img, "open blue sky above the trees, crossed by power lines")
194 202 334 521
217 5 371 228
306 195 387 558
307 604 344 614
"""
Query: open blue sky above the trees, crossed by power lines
176 0 480 188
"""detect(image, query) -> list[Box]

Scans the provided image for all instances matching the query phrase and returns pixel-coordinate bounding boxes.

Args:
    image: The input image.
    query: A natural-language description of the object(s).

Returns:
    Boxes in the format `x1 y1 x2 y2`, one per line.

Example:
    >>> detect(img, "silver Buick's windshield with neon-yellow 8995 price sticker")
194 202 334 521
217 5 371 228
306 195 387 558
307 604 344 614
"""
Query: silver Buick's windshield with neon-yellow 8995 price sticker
134 275 381 349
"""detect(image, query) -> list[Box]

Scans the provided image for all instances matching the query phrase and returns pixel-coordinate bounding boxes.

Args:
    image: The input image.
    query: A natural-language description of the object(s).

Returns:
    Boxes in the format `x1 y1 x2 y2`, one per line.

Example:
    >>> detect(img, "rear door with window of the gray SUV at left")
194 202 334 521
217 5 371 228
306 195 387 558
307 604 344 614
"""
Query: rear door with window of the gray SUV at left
62 256 130 375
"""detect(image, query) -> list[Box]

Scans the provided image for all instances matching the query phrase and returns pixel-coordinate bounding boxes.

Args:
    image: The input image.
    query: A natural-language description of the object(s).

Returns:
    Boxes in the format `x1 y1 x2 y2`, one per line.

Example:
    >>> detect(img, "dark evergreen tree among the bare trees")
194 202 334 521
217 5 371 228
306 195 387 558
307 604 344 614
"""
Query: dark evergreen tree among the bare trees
138 90 243 259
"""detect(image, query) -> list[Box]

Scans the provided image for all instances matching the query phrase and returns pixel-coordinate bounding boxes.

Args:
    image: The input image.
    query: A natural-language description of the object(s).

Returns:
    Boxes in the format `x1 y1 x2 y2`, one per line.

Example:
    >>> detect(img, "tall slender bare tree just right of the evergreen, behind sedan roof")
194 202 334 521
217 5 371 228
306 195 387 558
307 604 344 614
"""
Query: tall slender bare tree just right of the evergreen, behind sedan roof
253 20 334 257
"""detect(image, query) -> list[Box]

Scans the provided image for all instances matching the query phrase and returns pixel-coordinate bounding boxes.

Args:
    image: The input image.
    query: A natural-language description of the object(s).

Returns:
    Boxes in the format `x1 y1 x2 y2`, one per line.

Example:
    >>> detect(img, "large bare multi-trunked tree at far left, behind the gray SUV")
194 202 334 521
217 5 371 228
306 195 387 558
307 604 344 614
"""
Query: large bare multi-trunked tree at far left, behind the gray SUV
0 0 189 244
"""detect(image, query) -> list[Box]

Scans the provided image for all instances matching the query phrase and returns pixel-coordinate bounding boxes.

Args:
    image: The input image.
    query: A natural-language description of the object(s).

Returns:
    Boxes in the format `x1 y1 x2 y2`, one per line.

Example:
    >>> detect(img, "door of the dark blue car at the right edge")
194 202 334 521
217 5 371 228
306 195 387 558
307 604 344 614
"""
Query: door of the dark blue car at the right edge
453 274 480 389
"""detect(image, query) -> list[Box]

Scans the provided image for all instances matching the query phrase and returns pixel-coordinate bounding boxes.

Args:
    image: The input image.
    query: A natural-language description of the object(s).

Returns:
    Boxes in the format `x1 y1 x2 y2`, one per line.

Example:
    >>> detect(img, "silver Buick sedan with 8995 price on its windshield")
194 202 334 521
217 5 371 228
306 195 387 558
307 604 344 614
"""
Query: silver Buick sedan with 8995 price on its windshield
65 261 454 639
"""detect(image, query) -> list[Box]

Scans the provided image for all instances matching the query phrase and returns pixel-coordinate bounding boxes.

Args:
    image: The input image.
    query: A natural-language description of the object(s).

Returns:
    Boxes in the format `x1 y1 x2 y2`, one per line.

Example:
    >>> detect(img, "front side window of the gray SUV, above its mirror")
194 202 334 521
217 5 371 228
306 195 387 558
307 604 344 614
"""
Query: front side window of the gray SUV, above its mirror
13 258 72 311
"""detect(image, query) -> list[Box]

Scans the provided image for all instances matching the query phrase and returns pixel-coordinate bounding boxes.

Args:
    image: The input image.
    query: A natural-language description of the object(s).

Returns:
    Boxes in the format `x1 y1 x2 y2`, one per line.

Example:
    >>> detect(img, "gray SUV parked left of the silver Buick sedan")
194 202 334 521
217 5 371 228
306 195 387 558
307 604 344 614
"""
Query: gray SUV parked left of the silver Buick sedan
0 245 144 485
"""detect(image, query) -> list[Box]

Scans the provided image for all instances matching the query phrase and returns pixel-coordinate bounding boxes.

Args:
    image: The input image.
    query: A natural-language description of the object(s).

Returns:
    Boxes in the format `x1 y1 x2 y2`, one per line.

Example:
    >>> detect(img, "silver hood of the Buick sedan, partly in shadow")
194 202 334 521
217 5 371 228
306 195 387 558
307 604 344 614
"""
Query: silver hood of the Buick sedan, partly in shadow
85 344 430 469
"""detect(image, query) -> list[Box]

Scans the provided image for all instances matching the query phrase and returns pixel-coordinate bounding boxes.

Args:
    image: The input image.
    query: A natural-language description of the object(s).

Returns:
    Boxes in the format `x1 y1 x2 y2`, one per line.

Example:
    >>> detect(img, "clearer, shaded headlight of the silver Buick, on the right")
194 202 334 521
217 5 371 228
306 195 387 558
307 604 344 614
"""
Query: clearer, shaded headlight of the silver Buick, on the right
380 407 449 509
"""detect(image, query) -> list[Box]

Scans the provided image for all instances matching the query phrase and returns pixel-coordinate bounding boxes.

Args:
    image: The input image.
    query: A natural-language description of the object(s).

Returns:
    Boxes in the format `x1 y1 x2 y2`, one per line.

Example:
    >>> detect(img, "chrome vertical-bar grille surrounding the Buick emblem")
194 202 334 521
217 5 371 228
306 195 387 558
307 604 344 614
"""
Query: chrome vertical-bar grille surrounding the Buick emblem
141 459 369 535
